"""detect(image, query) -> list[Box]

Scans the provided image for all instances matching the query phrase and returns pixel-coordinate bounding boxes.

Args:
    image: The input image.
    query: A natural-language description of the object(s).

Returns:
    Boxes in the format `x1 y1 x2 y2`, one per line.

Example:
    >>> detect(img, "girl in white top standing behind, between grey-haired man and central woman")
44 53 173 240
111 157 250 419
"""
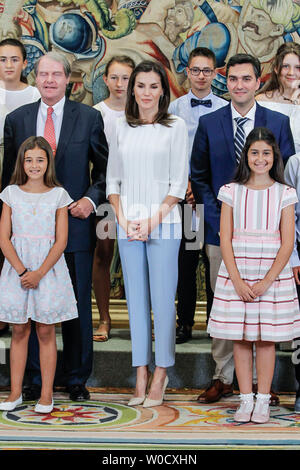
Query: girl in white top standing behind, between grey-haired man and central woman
93 56 135 342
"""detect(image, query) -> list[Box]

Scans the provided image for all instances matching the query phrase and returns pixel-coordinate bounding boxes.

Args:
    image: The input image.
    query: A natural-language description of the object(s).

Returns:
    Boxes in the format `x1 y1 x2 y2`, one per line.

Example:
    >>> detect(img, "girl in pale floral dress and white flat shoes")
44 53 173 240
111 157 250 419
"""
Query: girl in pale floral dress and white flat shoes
0 137 78 413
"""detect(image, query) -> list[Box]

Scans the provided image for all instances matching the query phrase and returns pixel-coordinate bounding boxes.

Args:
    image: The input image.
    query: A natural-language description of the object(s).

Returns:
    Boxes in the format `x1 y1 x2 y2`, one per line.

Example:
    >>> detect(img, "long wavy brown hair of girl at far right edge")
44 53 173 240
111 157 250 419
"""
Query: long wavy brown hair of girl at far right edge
257 42 300 98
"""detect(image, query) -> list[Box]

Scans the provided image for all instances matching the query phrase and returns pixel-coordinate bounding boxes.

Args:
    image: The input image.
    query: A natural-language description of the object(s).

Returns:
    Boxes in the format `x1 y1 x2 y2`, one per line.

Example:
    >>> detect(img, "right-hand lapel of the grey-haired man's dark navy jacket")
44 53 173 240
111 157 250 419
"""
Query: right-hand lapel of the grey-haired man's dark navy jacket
55 98 79 166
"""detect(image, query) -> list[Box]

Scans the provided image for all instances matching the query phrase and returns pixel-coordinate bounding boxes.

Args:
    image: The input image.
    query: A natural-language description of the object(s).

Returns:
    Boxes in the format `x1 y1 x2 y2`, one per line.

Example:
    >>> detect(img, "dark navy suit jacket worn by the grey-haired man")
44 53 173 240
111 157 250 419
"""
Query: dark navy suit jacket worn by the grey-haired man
2 99 108 252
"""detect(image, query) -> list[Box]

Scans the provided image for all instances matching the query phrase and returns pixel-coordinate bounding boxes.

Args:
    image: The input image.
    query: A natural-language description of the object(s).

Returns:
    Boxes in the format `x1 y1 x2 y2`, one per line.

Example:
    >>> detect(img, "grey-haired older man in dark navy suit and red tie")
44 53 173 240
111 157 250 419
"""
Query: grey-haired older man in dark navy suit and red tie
2 52 108 401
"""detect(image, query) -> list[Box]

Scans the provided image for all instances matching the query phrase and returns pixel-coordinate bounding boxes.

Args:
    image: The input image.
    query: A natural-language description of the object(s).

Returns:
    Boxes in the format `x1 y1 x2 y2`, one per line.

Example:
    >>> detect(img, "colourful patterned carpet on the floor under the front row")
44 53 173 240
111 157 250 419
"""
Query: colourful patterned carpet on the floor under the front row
0 391 300 450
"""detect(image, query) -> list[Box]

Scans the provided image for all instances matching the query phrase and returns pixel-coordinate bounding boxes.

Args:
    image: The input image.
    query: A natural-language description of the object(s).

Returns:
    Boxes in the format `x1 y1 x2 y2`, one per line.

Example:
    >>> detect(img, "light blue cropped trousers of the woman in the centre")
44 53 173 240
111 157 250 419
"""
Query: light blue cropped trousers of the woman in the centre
118 224 181 367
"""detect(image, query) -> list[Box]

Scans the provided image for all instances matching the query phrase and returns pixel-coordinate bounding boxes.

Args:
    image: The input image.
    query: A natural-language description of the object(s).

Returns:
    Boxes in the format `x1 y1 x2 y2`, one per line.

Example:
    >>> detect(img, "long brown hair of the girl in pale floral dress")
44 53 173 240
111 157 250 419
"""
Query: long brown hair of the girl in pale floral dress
10 136 61 188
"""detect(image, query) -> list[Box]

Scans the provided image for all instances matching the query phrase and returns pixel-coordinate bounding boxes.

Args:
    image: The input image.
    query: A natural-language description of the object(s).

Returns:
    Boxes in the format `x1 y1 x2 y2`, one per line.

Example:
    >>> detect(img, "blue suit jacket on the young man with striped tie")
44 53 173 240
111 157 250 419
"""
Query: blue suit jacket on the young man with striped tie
191 103 295 245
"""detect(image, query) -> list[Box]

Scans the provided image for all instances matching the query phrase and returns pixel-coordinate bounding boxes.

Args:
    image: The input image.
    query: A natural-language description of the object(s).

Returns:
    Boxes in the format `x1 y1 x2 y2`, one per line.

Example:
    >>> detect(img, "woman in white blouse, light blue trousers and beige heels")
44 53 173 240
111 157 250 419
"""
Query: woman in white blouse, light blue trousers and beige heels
107 61 188 407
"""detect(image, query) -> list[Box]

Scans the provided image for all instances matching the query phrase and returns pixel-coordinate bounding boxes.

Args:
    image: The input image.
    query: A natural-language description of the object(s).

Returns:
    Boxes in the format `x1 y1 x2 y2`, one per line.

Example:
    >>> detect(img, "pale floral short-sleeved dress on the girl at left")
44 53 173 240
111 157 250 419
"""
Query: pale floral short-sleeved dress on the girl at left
0 185 78 324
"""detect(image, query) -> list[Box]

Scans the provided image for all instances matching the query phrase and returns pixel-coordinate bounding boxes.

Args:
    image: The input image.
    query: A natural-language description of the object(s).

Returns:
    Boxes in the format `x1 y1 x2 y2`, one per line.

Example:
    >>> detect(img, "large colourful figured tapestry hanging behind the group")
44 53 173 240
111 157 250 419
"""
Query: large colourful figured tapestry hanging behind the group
0 0 300 300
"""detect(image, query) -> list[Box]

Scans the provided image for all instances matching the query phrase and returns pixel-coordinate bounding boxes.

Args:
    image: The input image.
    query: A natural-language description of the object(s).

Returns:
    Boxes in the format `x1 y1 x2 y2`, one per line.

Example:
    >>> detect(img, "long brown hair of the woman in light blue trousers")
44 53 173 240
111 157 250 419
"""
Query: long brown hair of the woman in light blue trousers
125 60 174 127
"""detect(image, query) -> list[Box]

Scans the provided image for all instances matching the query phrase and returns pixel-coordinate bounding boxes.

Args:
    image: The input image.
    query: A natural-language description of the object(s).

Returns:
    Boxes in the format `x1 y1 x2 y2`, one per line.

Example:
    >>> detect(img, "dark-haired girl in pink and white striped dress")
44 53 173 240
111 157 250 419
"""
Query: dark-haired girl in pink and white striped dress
208 128 300 423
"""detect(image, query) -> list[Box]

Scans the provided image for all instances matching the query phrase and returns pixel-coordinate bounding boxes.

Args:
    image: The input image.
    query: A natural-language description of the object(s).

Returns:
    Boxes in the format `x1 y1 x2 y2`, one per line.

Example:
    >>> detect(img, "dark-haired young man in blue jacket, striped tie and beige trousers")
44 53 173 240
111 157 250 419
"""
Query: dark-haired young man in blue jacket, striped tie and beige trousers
191 54 295 403
